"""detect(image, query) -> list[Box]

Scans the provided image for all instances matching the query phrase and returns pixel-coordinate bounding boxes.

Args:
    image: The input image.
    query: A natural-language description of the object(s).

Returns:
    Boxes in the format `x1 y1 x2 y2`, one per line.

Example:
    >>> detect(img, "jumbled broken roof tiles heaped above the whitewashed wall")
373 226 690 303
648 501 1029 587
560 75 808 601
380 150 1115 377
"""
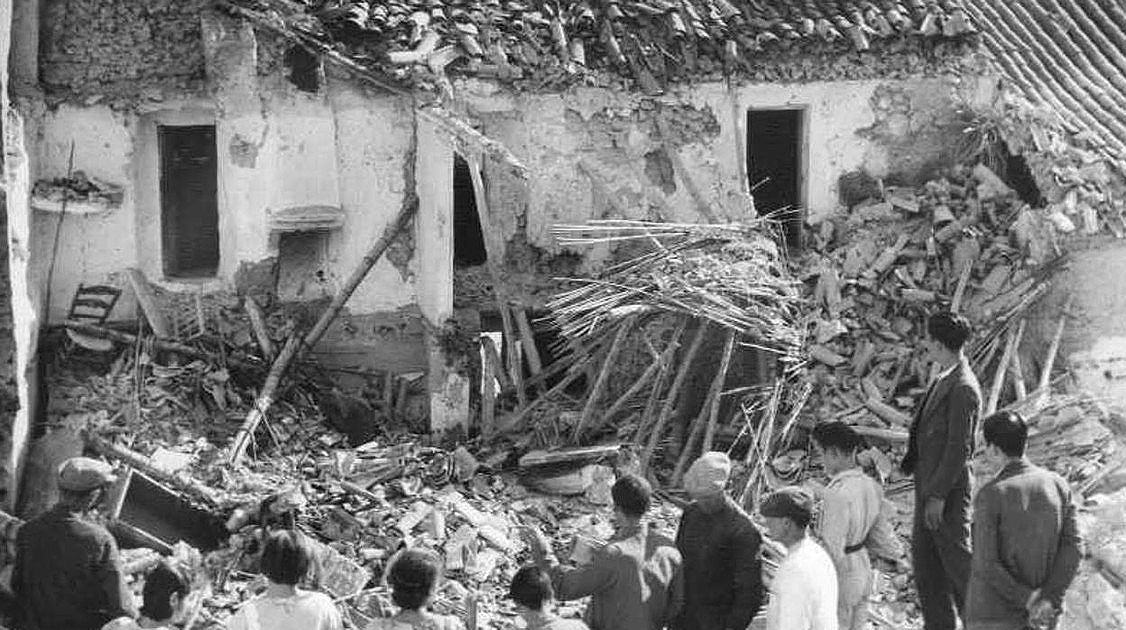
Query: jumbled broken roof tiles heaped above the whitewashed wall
223 0 976 93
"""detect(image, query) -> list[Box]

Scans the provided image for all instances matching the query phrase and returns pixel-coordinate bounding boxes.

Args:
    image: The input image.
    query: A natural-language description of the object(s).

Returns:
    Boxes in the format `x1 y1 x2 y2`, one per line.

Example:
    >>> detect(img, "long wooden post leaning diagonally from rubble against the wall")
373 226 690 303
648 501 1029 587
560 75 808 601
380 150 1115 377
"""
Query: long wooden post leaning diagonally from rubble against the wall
229 204 418 466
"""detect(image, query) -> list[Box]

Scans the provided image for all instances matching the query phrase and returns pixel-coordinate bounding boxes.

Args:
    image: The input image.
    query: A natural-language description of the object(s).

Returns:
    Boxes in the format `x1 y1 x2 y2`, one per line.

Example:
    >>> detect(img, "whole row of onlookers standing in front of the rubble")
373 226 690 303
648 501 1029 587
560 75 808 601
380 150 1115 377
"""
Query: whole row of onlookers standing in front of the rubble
6 313 1081 630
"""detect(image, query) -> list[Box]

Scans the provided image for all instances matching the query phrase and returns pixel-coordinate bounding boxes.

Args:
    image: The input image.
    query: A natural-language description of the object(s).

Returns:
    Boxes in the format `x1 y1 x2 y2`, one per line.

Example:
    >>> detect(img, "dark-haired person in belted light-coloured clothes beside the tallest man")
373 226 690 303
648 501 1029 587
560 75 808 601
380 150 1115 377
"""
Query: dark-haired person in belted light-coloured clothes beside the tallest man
813 422 903 630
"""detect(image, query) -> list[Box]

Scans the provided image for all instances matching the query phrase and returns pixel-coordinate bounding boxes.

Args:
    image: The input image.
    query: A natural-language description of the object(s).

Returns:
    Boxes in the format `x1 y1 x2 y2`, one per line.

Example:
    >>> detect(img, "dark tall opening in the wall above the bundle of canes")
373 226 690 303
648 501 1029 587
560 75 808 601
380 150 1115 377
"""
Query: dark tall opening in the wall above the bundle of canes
747 109 804 246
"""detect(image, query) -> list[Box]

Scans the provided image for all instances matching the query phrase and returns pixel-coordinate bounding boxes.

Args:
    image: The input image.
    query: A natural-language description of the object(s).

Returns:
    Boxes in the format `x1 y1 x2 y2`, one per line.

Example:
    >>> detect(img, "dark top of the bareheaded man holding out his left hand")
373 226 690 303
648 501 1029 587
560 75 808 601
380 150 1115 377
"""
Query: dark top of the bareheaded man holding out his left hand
552 525 682 630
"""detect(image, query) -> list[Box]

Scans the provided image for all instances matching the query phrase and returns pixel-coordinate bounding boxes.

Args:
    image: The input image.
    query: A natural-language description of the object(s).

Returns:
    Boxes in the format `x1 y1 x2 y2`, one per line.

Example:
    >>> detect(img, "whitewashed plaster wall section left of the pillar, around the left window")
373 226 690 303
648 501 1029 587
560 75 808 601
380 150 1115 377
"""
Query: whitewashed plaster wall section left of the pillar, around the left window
28 79 415 321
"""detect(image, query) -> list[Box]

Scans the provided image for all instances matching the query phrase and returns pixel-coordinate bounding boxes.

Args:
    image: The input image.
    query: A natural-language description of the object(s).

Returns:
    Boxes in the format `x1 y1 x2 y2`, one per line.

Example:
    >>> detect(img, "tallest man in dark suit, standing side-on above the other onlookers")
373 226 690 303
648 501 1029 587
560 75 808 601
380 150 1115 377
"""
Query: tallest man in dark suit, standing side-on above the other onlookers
900 313 981 630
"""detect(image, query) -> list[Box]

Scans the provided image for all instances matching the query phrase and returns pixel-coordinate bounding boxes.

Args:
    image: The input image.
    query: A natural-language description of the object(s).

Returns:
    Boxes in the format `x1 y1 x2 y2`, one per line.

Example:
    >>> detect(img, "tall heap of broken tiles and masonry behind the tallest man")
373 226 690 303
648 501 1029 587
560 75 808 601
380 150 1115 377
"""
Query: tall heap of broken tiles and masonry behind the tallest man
801 164 1064 438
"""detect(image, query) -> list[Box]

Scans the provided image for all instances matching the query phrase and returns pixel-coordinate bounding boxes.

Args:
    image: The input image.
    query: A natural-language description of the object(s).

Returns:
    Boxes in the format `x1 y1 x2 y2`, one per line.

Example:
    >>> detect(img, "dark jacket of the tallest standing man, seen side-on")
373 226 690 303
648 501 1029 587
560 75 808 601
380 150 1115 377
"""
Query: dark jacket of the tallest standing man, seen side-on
900 358 982 501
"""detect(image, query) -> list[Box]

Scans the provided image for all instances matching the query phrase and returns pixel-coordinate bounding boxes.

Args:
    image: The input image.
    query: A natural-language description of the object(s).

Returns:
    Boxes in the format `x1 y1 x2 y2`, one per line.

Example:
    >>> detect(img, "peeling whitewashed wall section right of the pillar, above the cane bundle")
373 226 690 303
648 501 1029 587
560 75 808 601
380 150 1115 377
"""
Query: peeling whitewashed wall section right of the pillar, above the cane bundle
459 77 989 271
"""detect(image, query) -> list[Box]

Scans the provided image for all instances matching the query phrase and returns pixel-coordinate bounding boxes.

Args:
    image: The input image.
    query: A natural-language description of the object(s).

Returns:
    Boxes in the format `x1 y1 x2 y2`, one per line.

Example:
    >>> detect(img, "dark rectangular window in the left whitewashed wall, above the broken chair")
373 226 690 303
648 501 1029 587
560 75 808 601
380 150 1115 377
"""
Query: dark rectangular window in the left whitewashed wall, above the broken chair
158 125 218 278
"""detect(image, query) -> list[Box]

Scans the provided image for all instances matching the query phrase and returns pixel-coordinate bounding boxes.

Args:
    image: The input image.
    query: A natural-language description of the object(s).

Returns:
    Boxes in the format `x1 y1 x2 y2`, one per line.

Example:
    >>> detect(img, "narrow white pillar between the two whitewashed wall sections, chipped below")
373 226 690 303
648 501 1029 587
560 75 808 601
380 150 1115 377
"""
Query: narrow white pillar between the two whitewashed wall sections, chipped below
414 117 470 433
